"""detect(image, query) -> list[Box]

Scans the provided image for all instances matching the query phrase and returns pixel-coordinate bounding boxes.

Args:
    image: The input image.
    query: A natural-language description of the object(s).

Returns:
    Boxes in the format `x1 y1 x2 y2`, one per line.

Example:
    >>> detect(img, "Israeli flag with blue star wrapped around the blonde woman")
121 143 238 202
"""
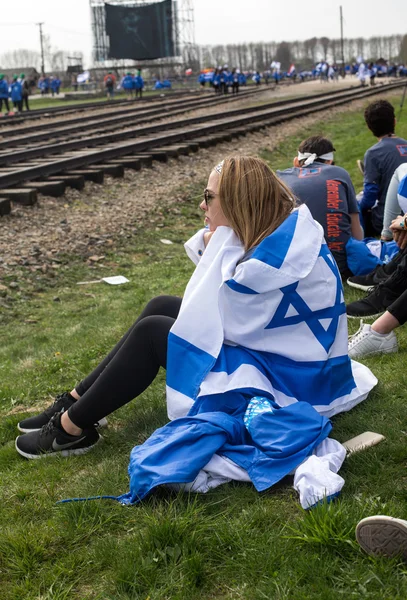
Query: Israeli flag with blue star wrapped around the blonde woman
167 205 377 419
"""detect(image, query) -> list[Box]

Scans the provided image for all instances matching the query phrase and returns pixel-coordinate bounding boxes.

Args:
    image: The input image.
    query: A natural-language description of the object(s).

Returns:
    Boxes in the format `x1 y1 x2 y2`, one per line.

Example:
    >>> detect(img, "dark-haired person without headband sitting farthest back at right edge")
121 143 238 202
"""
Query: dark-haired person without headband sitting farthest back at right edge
360 100 407 236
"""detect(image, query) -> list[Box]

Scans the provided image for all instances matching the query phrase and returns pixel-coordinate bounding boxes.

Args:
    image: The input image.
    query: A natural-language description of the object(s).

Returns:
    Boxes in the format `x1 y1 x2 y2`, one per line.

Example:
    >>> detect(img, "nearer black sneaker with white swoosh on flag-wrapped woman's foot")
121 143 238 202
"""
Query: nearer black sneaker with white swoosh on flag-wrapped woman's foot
16 412 101 458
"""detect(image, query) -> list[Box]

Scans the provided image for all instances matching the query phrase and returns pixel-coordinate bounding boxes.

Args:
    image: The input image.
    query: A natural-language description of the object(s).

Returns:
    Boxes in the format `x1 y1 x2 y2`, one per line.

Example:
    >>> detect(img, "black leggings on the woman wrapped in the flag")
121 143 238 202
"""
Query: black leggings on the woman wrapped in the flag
68 296 182 429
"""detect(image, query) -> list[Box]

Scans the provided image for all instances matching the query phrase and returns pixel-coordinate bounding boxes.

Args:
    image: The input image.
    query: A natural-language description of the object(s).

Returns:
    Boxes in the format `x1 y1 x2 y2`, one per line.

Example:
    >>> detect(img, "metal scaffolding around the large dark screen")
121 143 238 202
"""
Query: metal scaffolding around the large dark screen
90 0 196 66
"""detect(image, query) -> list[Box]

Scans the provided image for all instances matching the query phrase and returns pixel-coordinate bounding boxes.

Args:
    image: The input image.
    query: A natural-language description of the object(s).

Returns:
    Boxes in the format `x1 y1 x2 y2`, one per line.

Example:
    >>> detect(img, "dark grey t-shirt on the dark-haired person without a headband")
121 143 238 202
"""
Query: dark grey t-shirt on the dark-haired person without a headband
364 137 407 231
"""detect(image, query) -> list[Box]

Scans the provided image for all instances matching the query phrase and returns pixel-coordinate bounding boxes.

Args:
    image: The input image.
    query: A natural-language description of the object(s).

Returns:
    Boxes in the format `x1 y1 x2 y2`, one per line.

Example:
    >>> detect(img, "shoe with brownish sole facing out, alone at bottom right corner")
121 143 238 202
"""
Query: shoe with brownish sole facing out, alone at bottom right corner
356 515 407 561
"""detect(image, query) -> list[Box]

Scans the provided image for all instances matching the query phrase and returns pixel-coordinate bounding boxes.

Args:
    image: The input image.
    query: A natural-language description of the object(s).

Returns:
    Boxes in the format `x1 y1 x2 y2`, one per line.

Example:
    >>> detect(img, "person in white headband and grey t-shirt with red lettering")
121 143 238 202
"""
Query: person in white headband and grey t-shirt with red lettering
277 136 363 277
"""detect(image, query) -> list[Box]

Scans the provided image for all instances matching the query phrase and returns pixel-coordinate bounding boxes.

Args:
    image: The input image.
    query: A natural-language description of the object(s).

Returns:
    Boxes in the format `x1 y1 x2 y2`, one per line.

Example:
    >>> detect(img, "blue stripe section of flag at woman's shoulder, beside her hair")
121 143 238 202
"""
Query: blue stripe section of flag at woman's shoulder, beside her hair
252 210 298 269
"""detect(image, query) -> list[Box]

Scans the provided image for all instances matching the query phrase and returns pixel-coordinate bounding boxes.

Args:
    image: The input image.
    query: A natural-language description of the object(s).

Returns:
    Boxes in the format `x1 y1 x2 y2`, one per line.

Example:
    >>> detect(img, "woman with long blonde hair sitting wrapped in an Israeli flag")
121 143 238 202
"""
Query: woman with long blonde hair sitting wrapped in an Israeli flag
16 156 377 502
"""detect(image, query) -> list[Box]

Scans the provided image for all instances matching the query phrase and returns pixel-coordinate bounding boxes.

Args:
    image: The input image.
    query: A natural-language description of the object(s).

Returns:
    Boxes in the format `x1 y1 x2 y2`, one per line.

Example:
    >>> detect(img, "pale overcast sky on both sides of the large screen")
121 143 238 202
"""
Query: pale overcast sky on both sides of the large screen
0 0 407 67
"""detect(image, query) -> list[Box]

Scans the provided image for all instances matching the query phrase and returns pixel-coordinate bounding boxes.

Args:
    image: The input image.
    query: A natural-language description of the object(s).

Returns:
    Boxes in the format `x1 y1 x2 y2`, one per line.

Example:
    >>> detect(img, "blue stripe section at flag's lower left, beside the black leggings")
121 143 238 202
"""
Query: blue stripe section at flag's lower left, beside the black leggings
167 332 215 398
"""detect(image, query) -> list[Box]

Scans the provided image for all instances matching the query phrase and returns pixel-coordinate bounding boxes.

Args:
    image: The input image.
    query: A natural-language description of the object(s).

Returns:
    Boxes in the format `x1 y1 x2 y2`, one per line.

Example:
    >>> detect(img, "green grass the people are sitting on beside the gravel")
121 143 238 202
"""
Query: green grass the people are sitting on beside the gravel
0 91 407 600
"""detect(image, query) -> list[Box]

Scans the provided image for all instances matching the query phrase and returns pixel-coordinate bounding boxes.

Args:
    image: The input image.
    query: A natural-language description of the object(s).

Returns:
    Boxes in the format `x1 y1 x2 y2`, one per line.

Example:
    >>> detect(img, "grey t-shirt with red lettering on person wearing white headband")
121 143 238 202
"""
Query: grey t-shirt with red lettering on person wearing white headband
277 161 359 273
